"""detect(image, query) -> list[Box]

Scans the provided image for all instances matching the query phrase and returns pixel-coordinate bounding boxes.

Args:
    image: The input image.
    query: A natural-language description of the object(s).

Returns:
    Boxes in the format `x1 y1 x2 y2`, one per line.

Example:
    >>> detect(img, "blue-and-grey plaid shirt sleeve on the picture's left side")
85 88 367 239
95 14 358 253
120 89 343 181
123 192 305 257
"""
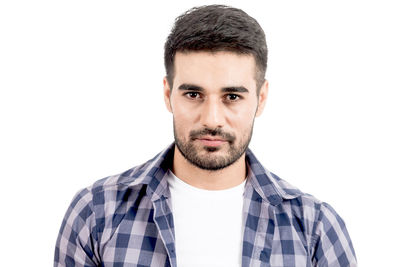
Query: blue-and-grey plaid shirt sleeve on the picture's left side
54 189 99 267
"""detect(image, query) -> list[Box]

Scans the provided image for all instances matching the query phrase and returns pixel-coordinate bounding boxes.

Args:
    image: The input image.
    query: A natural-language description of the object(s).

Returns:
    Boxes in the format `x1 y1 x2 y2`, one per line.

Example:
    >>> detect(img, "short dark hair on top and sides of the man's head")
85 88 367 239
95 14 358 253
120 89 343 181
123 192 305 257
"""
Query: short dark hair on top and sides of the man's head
164 5 268 95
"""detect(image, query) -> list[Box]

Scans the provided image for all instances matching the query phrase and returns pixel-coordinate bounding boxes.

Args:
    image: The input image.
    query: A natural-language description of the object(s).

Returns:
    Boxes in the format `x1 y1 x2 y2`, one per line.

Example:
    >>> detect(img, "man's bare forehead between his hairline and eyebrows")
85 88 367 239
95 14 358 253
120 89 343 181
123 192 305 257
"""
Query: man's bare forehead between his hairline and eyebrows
173 51 256 90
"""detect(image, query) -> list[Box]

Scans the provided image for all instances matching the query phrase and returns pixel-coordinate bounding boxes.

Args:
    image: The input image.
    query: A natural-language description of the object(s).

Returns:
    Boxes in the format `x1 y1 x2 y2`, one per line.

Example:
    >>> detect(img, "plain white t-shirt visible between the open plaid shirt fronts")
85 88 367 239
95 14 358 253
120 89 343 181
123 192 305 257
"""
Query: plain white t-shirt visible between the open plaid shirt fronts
167 171 246 267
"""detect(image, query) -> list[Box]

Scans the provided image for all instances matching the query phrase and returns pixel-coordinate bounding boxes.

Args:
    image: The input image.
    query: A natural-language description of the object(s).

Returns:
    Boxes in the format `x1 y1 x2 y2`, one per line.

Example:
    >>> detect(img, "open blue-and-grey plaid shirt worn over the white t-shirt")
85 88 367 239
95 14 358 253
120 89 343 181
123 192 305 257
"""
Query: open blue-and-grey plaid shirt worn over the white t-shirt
54 143 356 267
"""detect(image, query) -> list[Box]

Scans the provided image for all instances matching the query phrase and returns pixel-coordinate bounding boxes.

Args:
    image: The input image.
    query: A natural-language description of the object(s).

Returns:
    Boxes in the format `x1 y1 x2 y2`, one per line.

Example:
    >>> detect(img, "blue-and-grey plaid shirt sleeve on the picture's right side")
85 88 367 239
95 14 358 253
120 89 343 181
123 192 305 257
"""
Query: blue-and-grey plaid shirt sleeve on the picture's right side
311 203 357 267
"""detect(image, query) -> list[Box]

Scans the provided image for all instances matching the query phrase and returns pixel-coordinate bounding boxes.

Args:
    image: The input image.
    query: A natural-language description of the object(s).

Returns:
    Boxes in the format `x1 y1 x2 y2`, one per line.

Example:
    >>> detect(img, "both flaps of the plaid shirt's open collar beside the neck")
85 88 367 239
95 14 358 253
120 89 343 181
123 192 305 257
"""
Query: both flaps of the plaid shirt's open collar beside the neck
122 143 302 206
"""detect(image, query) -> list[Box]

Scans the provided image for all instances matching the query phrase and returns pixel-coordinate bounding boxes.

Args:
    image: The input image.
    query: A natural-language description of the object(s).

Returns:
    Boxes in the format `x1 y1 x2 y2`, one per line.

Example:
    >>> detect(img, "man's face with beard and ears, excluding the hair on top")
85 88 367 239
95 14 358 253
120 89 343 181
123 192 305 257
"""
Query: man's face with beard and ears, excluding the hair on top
164 52 268 170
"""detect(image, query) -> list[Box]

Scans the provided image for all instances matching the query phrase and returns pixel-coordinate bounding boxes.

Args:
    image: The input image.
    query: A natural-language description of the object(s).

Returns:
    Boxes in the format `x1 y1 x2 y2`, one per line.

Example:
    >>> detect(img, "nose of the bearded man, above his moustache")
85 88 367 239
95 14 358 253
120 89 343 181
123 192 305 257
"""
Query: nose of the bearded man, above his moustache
201 99 224 129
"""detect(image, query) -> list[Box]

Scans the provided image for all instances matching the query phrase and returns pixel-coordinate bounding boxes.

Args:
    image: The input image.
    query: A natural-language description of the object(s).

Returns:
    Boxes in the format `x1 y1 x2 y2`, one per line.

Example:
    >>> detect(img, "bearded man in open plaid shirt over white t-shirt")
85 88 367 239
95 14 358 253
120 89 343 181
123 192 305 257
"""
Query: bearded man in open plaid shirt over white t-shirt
54 5 356 267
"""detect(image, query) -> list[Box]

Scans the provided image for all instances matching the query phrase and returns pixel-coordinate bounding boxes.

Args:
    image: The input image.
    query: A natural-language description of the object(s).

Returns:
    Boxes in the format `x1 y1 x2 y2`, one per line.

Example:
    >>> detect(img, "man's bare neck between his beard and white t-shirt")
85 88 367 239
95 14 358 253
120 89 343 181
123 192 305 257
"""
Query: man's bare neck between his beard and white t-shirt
172 145 246 190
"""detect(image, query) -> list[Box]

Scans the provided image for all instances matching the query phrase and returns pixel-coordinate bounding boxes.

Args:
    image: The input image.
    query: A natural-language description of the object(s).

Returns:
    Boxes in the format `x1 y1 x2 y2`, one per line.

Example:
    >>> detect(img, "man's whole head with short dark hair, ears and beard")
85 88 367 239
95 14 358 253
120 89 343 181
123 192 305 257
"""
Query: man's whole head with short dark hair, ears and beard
164 6 268 170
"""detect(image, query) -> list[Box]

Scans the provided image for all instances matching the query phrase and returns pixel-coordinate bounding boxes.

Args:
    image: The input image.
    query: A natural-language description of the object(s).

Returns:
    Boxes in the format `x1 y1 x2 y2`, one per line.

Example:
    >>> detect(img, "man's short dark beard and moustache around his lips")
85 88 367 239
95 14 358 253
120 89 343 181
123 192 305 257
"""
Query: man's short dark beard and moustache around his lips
174 119 254 171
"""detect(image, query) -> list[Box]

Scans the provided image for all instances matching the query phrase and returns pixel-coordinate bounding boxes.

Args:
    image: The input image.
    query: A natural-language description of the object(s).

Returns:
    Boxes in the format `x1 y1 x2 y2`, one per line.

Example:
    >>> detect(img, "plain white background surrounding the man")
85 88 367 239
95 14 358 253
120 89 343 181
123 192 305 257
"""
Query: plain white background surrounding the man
0 0 400 267
